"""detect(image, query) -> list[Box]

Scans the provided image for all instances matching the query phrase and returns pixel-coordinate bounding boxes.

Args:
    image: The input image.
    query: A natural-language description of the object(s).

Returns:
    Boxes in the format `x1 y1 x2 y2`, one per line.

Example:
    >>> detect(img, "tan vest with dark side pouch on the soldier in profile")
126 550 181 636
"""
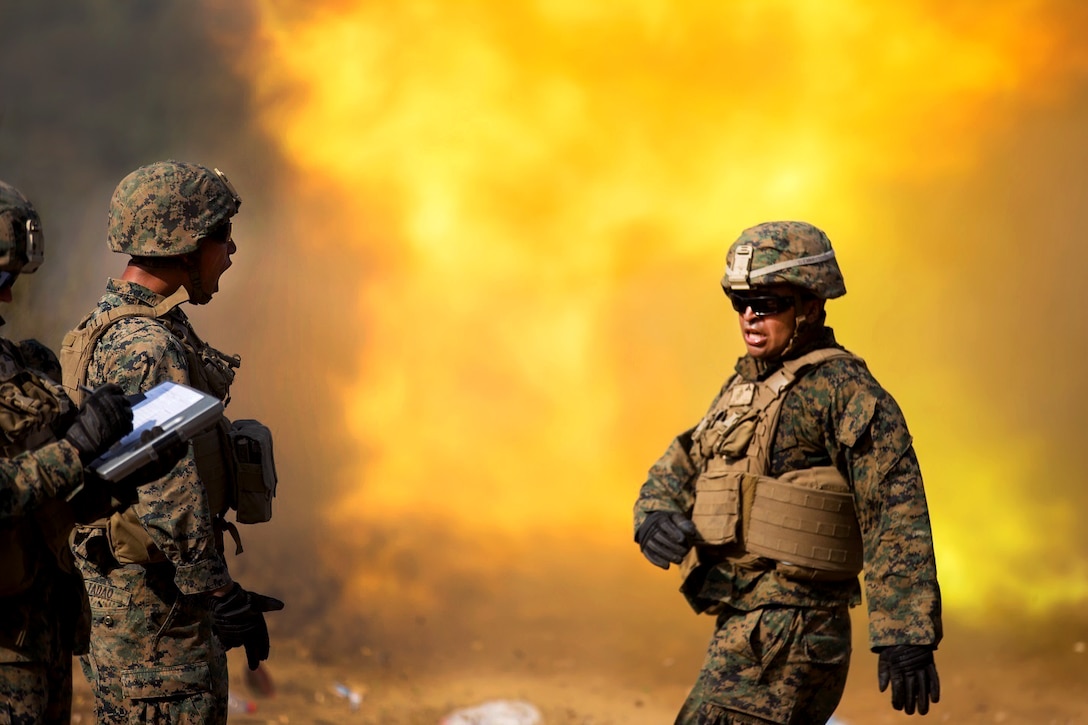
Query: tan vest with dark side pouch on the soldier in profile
60 287 276 564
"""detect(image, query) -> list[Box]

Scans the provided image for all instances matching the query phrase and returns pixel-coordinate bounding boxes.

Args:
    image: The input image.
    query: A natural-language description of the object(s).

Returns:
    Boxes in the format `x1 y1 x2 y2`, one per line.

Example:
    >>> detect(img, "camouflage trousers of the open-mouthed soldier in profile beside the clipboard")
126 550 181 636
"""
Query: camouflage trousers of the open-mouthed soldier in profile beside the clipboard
74 529 227 725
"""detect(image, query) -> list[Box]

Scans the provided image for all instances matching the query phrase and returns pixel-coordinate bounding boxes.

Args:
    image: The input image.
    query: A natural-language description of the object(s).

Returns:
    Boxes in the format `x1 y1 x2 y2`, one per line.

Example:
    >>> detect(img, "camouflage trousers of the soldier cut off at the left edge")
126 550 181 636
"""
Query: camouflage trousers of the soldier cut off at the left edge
0 652 72 725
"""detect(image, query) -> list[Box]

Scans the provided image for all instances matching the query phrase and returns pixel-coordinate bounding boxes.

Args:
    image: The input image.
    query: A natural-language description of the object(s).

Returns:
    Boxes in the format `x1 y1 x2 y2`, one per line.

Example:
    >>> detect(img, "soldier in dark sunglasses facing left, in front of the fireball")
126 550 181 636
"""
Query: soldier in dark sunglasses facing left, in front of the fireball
634 222 942 725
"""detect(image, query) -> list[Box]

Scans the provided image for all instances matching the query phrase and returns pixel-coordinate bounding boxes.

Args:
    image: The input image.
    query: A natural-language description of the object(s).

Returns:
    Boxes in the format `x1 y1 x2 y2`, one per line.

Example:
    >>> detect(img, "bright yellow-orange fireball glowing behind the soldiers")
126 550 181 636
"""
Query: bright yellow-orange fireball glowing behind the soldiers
236 0 1088 610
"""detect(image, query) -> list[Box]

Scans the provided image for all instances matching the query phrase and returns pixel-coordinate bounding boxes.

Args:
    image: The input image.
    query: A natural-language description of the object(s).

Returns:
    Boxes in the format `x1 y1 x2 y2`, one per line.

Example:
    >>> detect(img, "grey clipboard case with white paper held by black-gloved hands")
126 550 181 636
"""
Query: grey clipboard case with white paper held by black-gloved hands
88 382 223 481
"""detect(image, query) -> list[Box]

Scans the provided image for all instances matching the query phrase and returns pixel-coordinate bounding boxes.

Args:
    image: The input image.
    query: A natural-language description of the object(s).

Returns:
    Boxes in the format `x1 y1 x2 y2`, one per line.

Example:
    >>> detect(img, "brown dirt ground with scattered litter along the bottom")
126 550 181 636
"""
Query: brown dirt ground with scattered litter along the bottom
73 622 1088 725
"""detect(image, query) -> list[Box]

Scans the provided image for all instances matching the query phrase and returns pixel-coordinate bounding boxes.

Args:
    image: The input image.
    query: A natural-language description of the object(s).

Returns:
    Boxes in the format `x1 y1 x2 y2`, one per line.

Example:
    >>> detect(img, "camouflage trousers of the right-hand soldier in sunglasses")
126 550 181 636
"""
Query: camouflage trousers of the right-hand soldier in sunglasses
676 607 851 725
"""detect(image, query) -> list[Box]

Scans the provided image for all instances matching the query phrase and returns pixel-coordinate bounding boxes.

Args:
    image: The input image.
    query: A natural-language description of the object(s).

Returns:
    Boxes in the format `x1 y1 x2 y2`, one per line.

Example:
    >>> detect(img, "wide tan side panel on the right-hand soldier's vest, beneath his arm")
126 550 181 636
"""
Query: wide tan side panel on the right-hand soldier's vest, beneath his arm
747 466 863 581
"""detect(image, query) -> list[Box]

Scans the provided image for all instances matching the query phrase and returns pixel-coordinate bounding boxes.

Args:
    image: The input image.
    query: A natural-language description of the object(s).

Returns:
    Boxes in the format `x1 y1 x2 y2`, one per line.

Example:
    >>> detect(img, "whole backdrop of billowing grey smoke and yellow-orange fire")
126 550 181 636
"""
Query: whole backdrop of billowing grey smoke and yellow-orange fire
0 0 1088 683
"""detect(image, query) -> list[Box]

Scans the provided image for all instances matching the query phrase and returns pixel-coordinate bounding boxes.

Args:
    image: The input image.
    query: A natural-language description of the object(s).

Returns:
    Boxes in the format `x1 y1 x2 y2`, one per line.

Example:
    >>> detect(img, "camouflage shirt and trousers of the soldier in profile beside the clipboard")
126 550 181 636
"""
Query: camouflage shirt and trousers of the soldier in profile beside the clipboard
73 280 231 723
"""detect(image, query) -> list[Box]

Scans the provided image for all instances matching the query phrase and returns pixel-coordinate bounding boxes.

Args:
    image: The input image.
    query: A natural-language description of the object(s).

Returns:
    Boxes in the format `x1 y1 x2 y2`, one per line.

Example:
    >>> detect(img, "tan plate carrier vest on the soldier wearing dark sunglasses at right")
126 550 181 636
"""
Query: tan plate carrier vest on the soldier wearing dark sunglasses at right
681 348 863 589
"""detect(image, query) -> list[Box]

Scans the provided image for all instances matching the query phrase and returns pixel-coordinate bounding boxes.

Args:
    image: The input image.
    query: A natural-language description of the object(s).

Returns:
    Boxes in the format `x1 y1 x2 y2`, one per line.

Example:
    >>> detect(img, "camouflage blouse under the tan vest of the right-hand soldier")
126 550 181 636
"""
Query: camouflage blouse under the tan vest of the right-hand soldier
634 328 942 648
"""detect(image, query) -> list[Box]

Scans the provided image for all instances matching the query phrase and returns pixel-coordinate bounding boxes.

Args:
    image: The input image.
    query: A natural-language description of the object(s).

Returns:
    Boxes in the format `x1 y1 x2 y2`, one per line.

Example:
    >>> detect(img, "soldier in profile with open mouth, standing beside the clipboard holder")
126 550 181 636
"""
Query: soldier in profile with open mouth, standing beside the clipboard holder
61 161 283 724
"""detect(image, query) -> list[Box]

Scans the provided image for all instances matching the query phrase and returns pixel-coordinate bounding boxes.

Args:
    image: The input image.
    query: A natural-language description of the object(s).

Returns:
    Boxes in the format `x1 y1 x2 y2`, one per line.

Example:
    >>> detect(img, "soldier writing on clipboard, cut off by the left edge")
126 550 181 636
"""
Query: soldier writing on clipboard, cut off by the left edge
0 176 132 724
